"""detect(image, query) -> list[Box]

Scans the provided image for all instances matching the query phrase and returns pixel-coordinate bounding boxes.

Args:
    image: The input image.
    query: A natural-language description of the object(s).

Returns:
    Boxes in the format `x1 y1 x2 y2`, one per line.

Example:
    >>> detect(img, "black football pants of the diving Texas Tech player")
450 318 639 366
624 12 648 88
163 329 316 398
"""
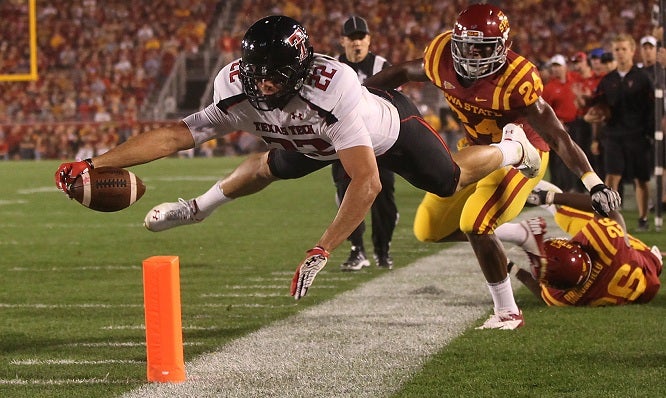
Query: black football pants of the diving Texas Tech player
268 88 460 196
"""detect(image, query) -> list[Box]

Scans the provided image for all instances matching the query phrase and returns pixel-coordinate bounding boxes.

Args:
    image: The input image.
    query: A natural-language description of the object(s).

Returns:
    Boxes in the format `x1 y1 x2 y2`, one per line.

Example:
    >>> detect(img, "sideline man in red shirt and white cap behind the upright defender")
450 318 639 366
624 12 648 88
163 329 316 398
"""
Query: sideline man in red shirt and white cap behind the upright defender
543 54 578 192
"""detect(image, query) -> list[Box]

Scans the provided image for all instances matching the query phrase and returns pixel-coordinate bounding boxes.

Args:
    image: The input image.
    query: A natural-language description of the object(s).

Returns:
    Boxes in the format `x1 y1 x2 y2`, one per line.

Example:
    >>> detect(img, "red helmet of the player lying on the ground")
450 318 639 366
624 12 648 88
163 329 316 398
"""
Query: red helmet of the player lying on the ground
532 238 592 290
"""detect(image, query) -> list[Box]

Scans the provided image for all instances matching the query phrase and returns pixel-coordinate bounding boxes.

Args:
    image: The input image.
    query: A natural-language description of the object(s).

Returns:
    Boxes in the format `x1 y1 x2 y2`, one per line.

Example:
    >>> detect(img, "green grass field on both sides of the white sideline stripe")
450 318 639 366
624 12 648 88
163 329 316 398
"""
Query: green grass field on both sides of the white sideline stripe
0 158 666 397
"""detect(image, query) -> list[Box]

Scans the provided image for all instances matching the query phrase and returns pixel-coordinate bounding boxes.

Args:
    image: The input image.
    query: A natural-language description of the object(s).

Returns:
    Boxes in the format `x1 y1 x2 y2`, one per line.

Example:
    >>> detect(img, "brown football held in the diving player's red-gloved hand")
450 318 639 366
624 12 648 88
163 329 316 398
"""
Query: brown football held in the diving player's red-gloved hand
70 167 146 212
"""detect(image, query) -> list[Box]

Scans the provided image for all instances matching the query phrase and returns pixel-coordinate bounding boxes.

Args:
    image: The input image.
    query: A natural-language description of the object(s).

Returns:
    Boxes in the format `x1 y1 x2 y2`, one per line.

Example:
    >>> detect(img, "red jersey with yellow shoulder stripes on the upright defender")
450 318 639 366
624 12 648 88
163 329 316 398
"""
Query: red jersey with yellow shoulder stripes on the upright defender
423 31 549 151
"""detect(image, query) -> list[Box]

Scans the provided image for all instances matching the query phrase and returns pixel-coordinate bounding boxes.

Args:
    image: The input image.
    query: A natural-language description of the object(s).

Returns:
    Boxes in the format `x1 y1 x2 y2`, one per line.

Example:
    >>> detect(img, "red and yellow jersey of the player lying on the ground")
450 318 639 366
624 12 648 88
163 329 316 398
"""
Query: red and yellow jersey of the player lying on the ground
541 218 662 307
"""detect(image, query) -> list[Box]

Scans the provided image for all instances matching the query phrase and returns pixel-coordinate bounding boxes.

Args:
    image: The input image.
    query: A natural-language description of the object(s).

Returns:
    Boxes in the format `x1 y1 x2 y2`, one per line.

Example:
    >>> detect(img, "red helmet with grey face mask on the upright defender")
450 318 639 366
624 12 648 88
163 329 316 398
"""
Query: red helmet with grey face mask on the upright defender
451 4 509 80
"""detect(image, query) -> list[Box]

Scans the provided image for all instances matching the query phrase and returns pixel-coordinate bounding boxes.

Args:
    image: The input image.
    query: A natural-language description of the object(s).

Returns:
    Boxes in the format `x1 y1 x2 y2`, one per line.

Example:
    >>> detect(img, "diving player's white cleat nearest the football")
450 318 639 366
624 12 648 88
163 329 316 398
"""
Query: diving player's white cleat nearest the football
143 198 205 232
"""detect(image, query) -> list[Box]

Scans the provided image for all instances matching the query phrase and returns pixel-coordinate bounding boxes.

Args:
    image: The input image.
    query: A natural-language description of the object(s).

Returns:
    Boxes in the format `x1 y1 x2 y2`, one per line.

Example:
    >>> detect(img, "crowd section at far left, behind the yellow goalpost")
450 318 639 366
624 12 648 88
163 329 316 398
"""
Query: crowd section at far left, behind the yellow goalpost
0 0 218 159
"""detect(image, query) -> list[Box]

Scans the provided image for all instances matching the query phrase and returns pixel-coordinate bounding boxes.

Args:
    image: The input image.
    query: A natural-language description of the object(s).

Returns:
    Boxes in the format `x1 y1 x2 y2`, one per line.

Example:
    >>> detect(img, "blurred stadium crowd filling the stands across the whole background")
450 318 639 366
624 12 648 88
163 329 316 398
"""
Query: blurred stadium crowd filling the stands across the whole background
0 0 652 159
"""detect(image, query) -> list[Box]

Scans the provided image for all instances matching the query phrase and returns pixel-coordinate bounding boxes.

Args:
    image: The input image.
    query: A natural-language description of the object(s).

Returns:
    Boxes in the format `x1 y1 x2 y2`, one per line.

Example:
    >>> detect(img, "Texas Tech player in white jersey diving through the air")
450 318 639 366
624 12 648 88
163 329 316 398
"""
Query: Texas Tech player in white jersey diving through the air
55 16 541 299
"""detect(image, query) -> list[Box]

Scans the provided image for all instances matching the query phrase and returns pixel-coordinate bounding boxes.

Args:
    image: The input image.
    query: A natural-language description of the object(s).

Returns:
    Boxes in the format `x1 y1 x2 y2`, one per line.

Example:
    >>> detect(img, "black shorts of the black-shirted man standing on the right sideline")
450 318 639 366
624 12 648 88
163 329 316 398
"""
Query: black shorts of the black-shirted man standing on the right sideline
603 136 652 181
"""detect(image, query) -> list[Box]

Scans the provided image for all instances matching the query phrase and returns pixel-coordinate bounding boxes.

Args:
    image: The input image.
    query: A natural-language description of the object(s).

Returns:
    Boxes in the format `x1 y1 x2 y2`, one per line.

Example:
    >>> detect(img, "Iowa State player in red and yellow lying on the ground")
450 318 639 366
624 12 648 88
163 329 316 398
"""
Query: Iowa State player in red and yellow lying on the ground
495 182 662 307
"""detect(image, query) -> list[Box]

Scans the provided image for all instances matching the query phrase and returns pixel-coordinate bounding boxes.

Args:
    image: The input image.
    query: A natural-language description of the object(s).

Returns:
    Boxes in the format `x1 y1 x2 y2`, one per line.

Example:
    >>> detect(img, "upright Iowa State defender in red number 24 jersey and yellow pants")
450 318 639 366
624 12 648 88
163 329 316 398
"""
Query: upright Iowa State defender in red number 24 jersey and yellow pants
365 4 620 329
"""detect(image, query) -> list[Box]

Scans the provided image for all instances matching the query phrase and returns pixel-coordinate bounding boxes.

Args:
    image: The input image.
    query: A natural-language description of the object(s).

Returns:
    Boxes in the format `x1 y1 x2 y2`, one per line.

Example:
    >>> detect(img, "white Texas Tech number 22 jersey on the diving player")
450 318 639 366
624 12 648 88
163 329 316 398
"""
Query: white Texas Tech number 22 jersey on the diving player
183 54 400 160
